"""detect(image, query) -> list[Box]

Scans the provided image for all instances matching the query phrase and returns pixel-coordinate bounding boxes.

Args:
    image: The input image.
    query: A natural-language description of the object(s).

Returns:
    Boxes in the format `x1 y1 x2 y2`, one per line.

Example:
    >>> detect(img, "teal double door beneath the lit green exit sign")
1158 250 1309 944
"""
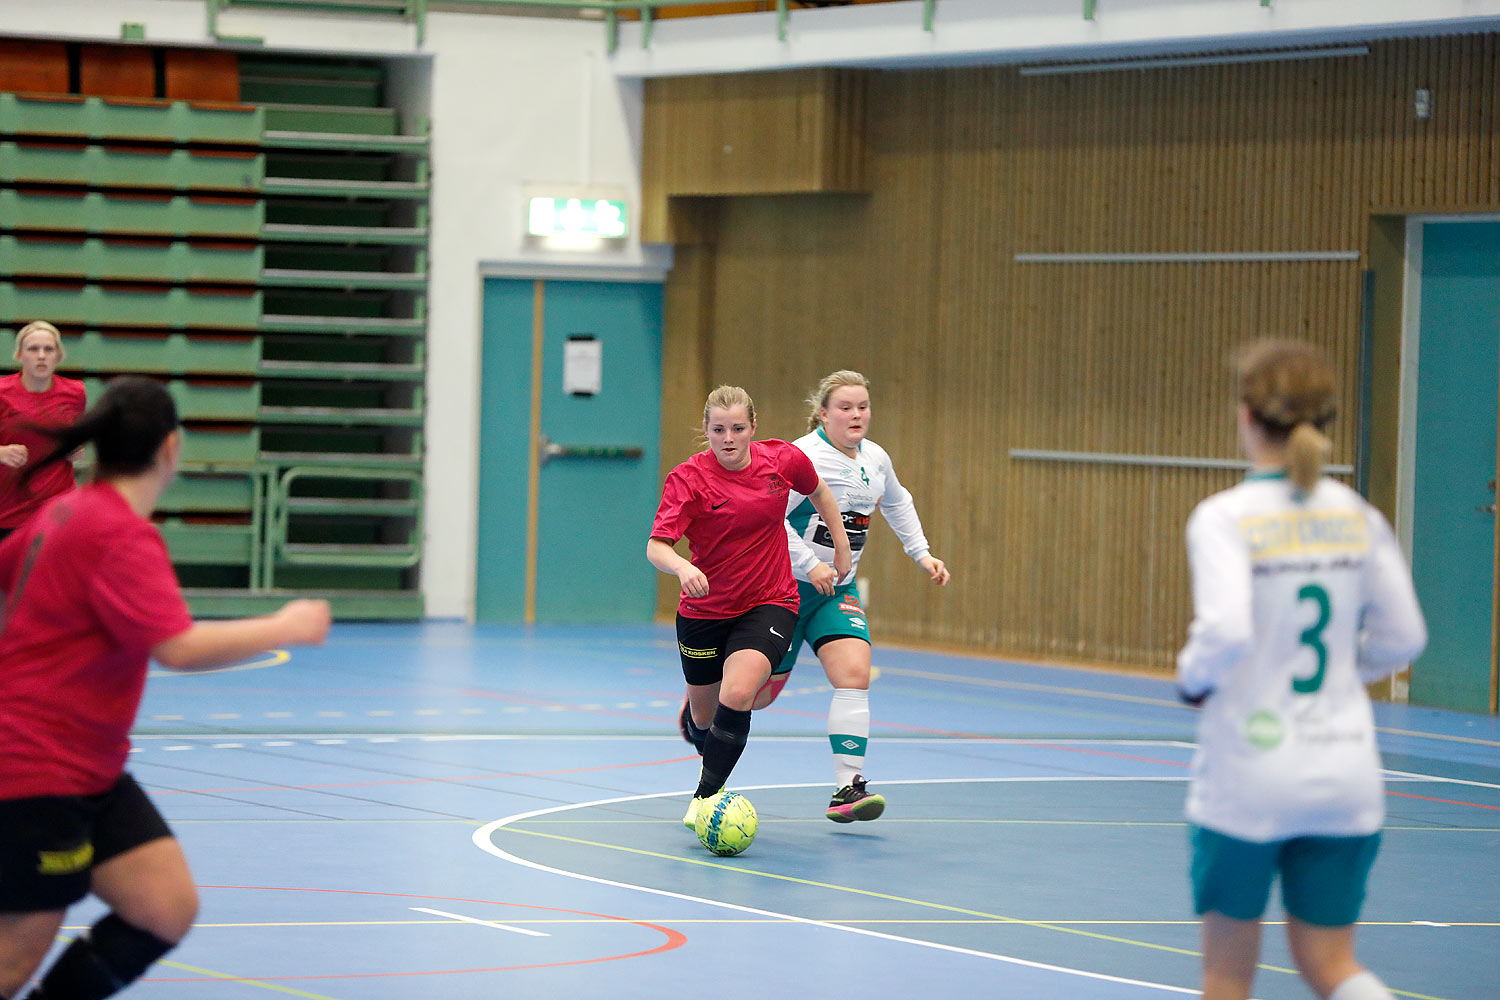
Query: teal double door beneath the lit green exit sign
476 279 662 624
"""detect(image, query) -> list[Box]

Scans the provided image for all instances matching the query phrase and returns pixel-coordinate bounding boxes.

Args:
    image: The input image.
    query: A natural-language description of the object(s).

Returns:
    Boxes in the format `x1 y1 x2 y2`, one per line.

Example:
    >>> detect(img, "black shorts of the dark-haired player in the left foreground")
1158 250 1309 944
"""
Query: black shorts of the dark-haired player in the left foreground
0 774 173 913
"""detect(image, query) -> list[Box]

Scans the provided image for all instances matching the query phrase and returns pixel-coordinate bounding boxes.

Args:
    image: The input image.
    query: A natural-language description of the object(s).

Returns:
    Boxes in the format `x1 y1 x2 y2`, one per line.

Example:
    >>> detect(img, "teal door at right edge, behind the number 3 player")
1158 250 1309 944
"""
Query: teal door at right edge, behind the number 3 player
1410 222 1500 712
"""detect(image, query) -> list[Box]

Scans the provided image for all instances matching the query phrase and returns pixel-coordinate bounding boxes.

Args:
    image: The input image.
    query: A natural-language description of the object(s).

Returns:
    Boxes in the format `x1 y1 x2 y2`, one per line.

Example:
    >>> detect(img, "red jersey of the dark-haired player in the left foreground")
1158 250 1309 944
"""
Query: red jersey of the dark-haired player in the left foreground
0 483 192 799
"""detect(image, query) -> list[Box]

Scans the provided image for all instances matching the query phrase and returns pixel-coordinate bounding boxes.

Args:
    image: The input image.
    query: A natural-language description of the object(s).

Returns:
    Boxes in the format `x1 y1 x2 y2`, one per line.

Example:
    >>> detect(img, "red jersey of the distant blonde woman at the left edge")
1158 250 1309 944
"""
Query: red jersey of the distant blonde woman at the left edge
0 372 86 528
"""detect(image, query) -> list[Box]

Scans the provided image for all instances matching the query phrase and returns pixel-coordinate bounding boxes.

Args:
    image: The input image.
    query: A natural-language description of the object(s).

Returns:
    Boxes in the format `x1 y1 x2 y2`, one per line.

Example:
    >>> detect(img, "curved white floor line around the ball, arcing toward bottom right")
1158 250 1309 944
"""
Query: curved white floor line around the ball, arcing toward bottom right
473 778 1199 997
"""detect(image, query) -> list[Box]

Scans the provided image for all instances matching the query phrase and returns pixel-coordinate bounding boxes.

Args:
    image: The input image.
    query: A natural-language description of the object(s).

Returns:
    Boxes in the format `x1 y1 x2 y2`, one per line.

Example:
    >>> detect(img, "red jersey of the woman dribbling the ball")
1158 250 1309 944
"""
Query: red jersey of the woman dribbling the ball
651 439 818 618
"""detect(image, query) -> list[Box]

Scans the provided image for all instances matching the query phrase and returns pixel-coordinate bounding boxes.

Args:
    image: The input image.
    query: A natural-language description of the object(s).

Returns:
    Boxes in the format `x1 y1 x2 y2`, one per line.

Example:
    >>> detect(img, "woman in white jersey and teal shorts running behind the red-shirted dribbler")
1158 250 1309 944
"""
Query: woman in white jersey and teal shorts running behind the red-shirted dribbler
755 370 948 823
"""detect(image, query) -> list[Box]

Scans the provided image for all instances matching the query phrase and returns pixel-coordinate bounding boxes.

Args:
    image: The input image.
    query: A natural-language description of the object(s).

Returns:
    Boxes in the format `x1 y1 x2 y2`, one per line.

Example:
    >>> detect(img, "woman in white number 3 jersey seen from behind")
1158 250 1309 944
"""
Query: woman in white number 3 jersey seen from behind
1178 342 1427 1000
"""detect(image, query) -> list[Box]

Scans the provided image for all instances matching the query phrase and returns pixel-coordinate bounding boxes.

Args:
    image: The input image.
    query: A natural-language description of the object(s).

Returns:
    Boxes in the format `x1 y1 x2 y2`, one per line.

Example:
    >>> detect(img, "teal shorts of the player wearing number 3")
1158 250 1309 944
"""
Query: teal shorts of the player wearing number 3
1188 825 1380 927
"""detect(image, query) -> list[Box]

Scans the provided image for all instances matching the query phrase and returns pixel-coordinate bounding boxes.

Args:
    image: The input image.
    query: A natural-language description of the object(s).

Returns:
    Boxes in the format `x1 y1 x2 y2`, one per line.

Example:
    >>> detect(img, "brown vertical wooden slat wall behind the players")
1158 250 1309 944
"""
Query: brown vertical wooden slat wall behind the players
644 36 1500 670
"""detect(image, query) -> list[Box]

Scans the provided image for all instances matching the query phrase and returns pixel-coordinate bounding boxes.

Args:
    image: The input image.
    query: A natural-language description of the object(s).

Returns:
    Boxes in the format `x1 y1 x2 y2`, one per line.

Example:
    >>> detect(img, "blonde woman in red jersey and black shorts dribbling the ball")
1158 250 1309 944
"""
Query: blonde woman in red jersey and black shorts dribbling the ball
647 385 852 826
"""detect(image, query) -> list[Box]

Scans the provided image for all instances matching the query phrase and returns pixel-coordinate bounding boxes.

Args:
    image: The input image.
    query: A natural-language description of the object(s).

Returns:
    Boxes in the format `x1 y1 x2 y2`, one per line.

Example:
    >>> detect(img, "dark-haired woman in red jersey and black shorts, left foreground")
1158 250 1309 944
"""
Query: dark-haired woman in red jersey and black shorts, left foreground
0 378 329 1000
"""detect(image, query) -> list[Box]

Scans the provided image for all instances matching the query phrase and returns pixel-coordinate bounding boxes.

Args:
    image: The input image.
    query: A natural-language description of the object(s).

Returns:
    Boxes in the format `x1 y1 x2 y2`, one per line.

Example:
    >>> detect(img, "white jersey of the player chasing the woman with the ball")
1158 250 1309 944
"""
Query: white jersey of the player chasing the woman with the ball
786 429 930 583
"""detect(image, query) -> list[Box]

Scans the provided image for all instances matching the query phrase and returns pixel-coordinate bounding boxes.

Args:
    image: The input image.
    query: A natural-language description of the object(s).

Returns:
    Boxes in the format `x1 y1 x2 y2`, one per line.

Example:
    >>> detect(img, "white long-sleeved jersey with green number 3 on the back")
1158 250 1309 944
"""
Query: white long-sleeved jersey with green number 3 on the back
1178 472 1427 843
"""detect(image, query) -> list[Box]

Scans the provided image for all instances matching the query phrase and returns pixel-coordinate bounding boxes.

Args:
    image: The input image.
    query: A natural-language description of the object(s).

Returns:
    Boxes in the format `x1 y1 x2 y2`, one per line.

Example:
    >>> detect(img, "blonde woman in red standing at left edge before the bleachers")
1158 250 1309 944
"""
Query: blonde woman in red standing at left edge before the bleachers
0 319 84 538
